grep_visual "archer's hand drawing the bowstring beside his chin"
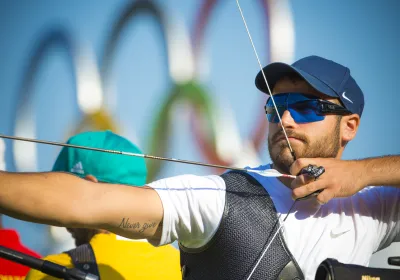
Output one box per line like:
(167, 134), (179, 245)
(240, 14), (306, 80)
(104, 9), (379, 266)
(290, 158), (367, 204)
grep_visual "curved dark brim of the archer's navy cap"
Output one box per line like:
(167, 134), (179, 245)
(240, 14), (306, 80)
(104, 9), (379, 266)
(255, 62), (338, 97)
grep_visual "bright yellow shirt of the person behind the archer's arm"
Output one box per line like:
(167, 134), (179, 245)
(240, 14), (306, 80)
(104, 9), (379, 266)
(26, 233), (182, 280)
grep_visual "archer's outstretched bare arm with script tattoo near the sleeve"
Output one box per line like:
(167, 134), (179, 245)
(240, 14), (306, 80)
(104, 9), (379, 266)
(0, 171), (163, 240)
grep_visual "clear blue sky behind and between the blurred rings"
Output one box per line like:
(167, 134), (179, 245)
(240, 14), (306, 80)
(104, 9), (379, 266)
(0, 0), (400, 262)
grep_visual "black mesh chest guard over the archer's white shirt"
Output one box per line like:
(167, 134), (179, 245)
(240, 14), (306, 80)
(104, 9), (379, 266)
(180, 171), (304, 280)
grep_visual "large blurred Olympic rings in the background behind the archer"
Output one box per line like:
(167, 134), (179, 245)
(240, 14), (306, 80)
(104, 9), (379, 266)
(11, 0), (294, 180)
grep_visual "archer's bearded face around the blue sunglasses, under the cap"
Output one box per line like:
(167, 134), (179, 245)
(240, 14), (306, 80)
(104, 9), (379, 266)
(268, 78), (341, 173)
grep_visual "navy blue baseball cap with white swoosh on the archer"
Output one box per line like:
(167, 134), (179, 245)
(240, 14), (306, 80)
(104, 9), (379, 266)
(255, 55), (364, 117)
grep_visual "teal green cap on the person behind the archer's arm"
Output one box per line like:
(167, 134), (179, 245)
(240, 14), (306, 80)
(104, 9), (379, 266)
(53, 130), (147, 186)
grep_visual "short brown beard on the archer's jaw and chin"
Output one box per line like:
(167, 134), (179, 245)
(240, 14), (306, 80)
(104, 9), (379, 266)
(268, 118), (340, 174)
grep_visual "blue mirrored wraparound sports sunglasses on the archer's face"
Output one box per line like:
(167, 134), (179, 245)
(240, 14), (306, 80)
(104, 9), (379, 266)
(265, 92), (352, 123)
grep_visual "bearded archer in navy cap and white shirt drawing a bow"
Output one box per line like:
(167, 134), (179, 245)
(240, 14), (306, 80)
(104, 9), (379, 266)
(0, 56), (400, 279)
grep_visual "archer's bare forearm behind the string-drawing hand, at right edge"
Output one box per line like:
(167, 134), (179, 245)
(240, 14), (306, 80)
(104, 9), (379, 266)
(355, 156), (400, 187)
